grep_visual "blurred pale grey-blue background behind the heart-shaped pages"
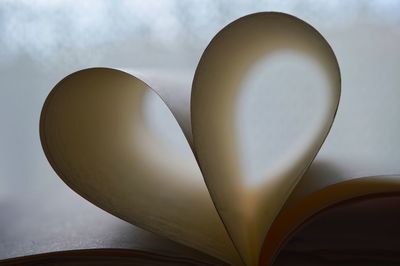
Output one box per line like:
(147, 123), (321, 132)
(0, 0), (400, 258)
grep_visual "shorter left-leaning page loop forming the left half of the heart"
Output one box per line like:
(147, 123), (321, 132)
(40, 68), (240, 265)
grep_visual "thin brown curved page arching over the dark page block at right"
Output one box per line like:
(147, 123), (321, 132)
(260, 176), (400, 265)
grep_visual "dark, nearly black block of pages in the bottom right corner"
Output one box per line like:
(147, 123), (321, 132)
(274, 192), (400, 266)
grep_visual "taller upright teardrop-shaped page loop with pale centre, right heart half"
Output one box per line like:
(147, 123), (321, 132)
(191, 13), (340, 265)
